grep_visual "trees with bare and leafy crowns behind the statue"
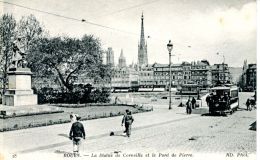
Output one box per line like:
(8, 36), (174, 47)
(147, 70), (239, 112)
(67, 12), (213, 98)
(0, 14), (111, 99)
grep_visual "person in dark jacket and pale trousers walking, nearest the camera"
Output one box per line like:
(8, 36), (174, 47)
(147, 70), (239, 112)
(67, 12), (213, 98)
(69, 115), (85, 153)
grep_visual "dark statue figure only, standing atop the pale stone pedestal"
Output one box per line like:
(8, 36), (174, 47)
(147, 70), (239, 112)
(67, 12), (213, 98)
(12, 37), (27, 68)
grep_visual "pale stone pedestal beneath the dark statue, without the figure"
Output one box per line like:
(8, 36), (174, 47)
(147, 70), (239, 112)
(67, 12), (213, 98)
(3, 68), (38, 106)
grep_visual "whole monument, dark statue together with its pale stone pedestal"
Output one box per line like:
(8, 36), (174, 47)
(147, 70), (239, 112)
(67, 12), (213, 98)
(3, 37), (38, 106)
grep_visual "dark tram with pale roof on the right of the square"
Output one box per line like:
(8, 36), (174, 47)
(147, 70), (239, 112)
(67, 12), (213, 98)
(206, 86), (239, 114)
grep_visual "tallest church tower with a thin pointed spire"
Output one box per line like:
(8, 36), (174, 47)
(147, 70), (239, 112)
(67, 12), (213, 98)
(138, 13), (148, 67)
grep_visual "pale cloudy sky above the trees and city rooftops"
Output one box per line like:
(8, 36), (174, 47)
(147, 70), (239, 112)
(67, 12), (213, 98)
(0, 0), (257, 67)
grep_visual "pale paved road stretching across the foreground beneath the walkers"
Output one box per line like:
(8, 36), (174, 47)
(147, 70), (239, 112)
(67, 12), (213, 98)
(0, 93), (256, 159)
